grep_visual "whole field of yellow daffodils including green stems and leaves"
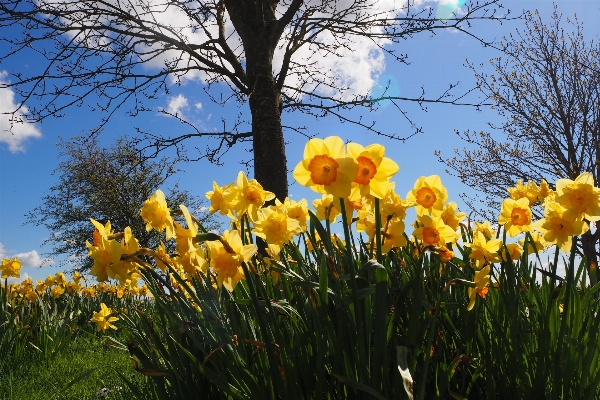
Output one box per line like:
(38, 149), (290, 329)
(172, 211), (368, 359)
(0, 136), (600, 400)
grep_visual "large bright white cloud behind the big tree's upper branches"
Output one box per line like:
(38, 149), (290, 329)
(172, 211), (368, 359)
(49, 0), (458, 105)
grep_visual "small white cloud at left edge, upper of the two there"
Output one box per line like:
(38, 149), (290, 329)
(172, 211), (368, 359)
(0, 71), (42, 153)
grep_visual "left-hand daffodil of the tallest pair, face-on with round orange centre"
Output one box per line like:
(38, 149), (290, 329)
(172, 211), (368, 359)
(294, 136), (358, 198)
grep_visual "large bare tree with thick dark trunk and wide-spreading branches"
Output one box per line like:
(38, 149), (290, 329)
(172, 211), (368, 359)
(0, 0), (507, 199)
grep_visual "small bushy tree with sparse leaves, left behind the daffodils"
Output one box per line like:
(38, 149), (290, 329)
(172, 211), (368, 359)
(27, 138), (218, 271)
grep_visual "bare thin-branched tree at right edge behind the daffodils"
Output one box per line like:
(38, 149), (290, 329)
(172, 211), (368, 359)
(440, 6), (600, 278)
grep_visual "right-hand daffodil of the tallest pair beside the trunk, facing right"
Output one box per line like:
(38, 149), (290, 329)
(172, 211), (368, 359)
(347, 143), (399, 199)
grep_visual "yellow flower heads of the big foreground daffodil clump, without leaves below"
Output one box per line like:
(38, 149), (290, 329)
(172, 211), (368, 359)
(82, 136), (600, 312)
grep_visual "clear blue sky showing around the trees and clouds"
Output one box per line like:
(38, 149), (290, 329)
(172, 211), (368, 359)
(0, 0), (600, 279)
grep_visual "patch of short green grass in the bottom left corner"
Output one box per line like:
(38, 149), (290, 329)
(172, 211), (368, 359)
(0, 327), (149, 400)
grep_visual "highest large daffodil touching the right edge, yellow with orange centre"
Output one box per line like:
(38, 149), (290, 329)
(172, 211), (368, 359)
(556, 172), (600, 221)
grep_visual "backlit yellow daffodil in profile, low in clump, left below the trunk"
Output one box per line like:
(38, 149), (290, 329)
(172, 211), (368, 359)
(207, 230), (258, 292)
